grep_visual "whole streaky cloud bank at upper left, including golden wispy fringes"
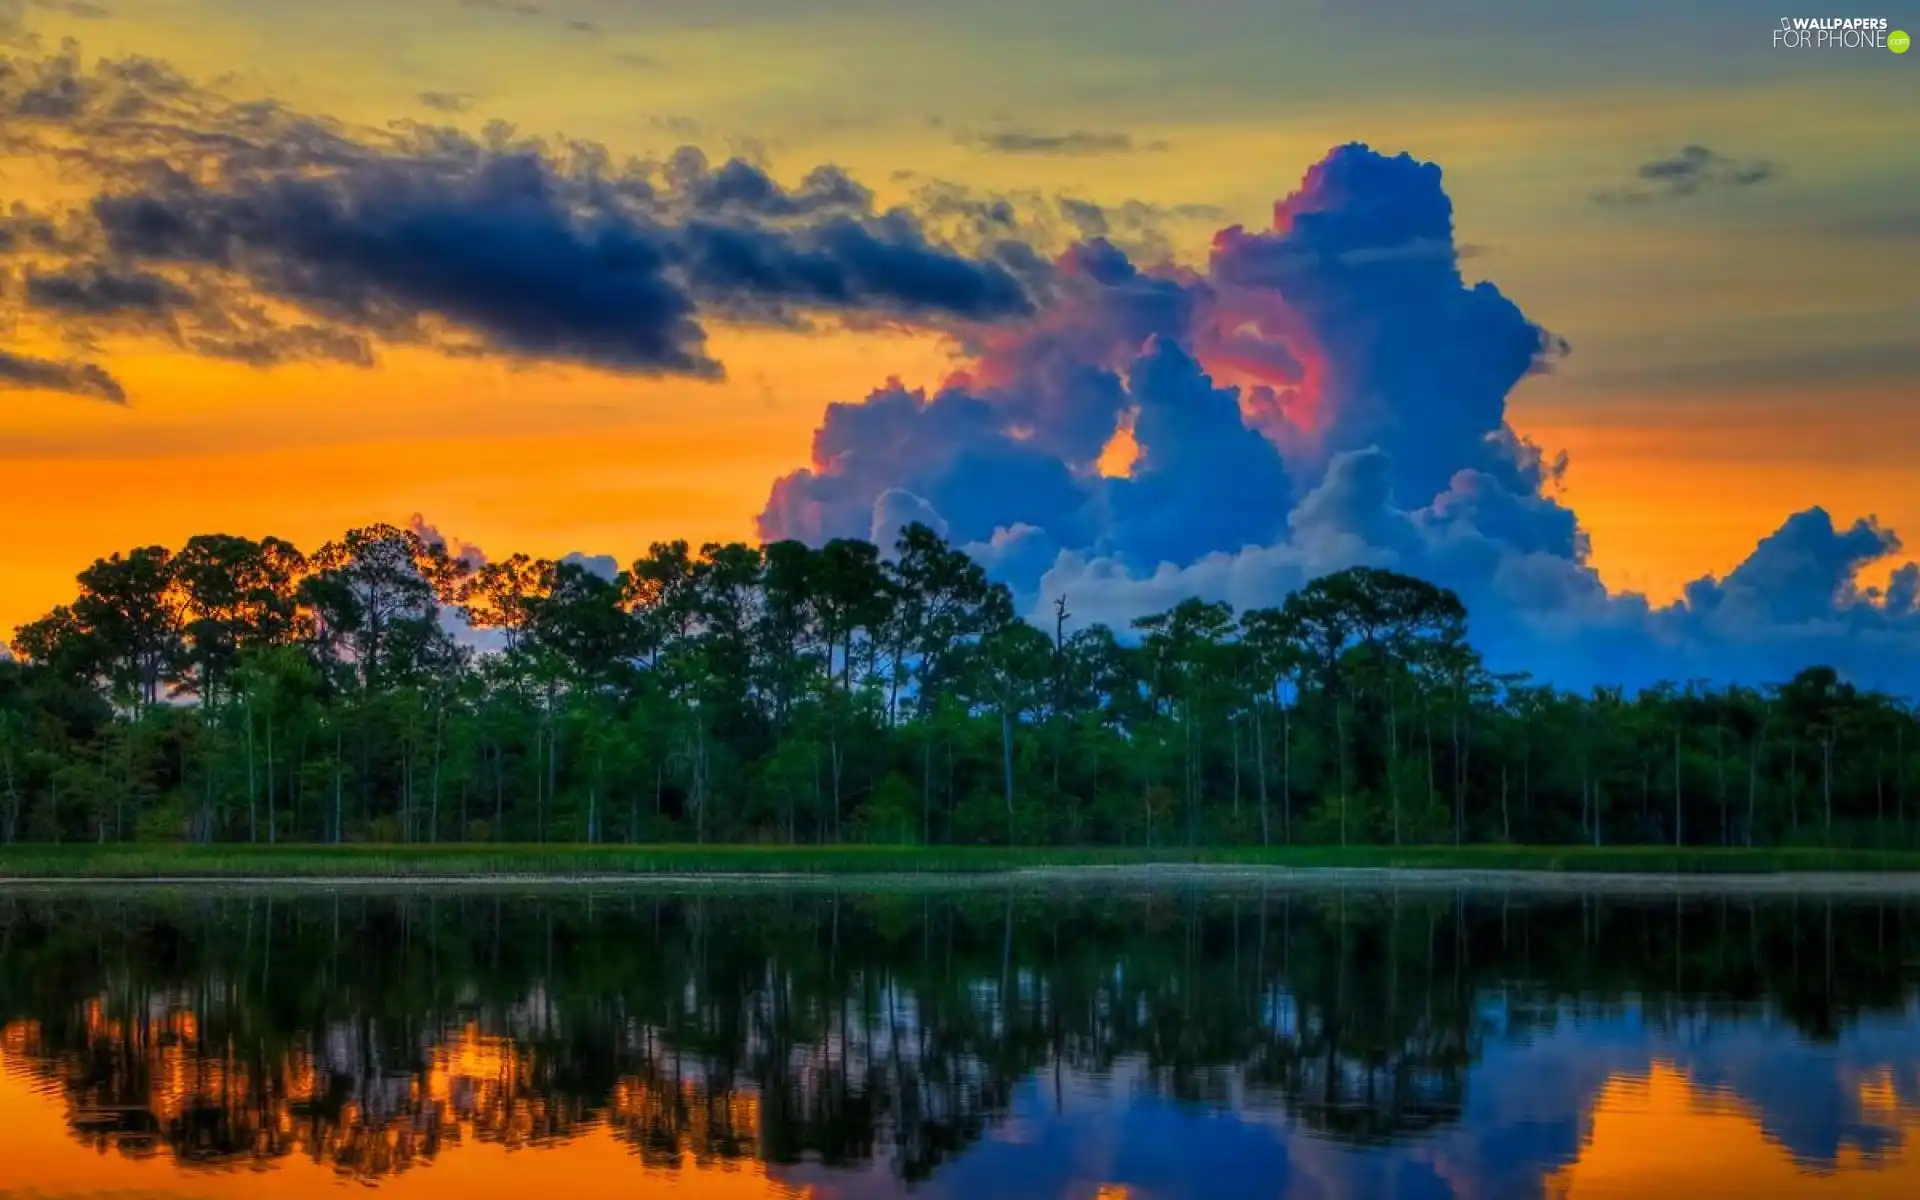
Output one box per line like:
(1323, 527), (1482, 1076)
(0, 46), (1043, 393)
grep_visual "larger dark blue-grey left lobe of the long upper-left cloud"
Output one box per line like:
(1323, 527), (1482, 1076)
(94, 157), (718, 374)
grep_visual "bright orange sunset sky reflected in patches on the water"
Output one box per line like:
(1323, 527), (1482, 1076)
(18, 1023), (1920, 1200)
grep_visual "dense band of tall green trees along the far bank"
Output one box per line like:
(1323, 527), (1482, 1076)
(0, 524), (1920, 847)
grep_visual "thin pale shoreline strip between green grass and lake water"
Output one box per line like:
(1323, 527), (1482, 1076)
(11, 864), (1920, 899)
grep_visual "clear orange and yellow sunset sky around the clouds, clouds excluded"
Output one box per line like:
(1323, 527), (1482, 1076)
(0, 0), (1920, 630)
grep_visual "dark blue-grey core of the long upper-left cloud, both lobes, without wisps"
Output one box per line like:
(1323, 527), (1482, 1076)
(82, 152), (1029, 374)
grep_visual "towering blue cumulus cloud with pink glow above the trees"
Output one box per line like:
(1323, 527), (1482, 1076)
(760, 144), (1920, 687)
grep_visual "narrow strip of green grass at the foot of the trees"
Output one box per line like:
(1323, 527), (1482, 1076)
(0, 845), (1920, 879)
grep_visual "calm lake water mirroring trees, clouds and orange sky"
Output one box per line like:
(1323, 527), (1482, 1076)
(0, 891), (1920, 1200)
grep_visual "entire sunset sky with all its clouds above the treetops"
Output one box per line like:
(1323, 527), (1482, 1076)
(0, 0), (1920, 682)
